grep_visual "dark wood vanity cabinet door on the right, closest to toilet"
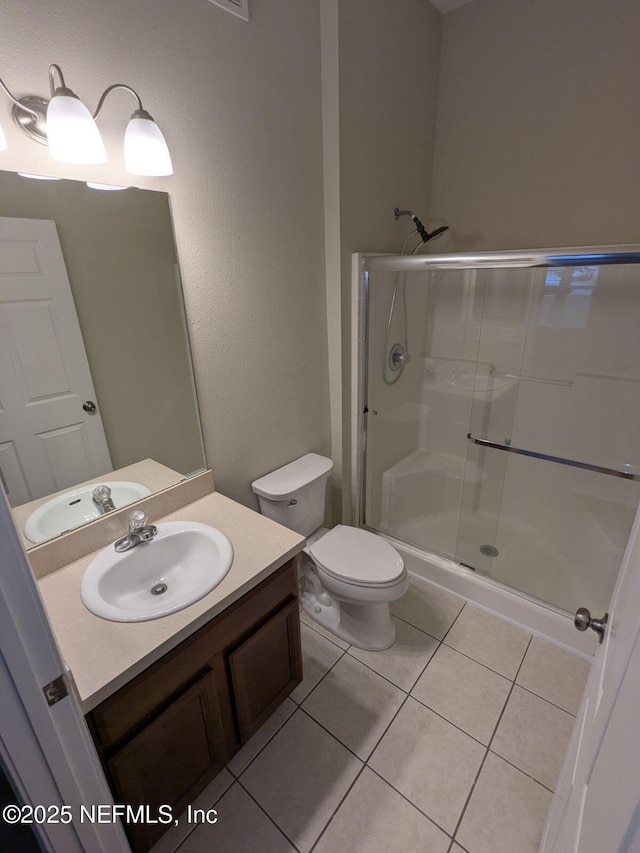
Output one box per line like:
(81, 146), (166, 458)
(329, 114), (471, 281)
(228, 599), (302, 743)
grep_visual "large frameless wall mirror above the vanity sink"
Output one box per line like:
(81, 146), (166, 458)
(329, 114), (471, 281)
(0, 172), (206, 548)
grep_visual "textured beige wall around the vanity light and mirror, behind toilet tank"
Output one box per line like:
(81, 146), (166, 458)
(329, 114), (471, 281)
(0, 0), (329, 506)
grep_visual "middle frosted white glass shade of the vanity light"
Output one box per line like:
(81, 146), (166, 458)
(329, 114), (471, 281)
(47, 95), (107, 164)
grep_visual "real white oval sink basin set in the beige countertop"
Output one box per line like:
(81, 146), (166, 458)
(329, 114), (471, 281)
(80, 521), (233, 622)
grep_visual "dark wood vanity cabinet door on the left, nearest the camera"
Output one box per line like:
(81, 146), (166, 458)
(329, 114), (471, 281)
(107, 670), (225, 851)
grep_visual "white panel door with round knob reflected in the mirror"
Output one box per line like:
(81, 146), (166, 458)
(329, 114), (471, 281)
(0, 217), (113, 506)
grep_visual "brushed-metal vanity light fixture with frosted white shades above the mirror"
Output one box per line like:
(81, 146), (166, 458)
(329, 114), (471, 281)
(0, 65), (173, 177)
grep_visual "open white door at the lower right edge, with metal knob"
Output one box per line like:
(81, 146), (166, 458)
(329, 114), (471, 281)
(540, 500), (640, 853)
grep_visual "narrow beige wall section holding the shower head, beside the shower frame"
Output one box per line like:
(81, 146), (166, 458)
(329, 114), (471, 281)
(325, 0), (441, 517)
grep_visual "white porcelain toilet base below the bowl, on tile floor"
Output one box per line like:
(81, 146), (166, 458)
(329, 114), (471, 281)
(302, 590), (396, 652)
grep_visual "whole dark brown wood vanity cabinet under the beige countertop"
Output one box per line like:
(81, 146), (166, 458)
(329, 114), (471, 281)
(87, 560), (302, 853)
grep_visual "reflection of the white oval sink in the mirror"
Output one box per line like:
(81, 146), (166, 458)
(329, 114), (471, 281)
(24, 480), (151, 545)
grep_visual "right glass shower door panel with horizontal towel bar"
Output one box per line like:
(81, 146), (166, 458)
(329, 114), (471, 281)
(456, 265), (640, 612)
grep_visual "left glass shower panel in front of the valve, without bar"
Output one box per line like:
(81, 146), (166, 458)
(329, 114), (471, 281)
(365, 270), (485, 559)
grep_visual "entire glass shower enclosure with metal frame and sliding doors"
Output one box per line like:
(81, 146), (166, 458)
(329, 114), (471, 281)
(358, 246), (640, 612)
